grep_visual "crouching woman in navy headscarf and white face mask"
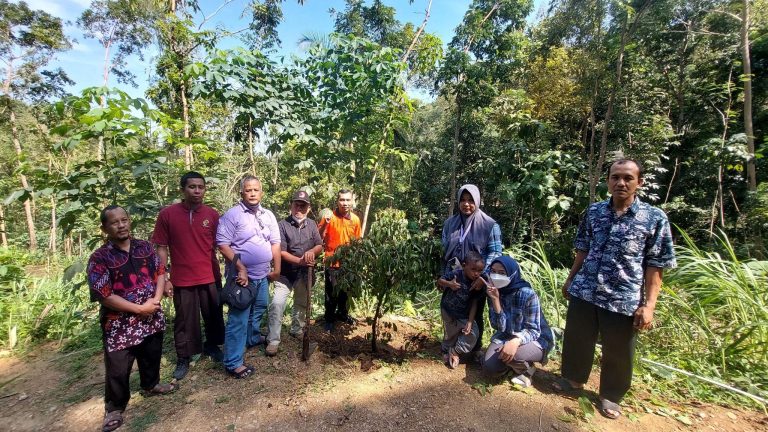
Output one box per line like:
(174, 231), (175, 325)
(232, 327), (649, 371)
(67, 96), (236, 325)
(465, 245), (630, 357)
(483, 256), (554, 387)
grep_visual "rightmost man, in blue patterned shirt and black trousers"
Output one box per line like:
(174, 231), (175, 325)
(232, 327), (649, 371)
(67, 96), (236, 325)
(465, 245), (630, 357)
(554, 159), (676, 419)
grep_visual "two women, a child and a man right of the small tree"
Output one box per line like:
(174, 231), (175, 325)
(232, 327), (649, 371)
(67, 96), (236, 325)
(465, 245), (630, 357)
(437, 159), (676, 419)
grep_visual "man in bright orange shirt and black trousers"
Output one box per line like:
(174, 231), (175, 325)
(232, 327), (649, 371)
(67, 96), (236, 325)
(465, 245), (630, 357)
(319, 189), (362, 331)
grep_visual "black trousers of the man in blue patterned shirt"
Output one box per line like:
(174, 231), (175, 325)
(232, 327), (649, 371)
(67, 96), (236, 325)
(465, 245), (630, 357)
(561, 297), (637, 403)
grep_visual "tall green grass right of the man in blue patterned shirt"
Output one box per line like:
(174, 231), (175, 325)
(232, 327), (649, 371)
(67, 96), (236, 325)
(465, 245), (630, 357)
(648, 232), (768, 404)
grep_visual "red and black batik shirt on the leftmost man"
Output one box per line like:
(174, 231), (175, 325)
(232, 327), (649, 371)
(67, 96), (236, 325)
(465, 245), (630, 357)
(87, 239), (165, 352)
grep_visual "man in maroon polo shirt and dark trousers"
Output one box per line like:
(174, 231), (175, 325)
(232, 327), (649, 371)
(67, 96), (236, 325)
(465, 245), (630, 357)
(152, 171), (224, 380)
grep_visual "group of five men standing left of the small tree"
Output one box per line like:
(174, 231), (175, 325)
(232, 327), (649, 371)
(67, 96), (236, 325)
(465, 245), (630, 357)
(87, 172), (361, 431)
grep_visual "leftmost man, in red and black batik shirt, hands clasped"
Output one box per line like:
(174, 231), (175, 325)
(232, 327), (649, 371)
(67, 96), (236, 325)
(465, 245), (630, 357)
(87, 205), (176, 431)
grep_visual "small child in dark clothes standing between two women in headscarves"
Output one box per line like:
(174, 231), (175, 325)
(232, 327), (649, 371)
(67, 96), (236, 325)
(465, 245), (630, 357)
(437, 251), (485, 369)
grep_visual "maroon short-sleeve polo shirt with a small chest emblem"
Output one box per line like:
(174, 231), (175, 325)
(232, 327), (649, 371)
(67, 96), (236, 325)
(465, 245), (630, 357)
(152, 202), (221, 287)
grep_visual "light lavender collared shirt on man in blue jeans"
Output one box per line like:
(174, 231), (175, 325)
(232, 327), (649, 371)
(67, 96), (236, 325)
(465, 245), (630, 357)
(216, 201), (280, 280)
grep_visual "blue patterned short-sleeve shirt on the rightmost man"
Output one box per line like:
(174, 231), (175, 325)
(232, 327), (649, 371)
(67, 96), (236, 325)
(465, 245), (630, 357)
(568, 198), (677, 316)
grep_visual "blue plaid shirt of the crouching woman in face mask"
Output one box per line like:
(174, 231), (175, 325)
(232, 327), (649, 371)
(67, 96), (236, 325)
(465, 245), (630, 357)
(488, 287), (554, 352)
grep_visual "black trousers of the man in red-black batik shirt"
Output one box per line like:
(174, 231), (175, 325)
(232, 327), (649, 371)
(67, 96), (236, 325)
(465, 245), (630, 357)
(104, 332), (164, 412)
